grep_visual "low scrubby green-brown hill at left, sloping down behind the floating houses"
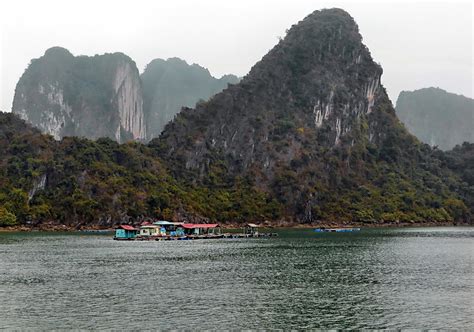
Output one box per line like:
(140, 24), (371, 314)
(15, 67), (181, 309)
(0, 113), (279, 227)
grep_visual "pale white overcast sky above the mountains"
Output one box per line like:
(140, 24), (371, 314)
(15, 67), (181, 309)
(0, 0), (473, 111)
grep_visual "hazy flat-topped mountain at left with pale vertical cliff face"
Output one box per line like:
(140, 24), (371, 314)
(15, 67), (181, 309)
(12, 47), (146, 142)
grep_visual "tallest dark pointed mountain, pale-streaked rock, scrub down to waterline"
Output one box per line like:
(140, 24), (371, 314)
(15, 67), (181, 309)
(157, 9), (468, 221)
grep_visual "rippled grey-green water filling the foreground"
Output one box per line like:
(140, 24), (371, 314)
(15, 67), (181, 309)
(0, 228), (474, 330)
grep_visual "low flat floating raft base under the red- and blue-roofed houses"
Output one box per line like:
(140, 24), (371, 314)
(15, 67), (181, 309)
(114, 233), (278, 241)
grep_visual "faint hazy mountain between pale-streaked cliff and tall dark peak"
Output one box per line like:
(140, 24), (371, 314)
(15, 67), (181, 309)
(141, 58), (239, 139)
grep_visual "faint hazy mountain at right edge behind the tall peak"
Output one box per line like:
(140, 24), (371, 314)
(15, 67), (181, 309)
(396, 88), (474, 150)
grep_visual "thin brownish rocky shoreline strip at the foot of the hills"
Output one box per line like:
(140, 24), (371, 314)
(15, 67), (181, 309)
(0, 222), (474, 233)
